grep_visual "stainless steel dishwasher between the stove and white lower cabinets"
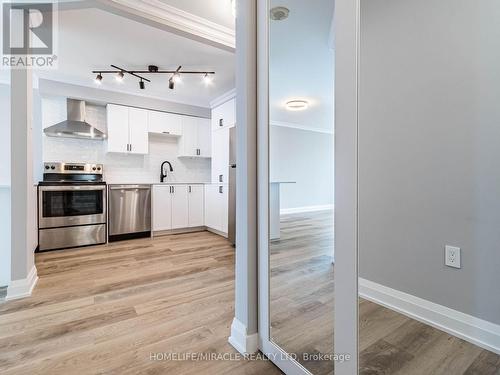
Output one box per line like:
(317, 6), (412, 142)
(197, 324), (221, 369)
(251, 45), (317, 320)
(108, 185), (151, 242)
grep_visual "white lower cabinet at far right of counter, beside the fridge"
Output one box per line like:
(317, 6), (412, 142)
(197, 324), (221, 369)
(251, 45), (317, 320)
(205, 184), (228, 233)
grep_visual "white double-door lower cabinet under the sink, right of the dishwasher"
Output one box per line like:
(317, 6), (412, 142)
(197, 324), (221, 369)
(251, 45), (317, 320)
(152, 185), (205, 232)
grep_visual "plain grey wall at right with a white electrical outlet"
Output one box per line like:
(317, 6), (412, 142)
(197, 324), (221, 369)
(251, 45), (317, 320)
(359, 0), (500, 324)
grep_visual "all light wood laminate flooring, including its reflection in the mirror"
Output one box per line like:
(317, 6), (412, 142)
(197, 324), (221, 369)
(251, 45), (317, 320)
(0, 213), (500, 375)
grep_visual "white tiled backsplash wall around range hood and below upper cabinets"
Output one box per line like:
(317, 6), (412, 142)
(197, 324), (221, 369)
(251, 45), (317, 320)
(42, 96), (210, 183)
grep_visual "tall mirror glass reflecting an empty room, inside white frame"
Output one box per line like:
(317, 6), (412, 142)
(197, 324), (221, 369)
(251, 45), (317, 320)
(269, 0), (334, 374)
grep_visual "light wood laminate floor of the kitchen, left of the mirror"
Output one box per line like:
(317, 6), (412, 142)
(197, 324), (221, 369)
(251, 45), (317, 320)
(0, 232), (281, 375)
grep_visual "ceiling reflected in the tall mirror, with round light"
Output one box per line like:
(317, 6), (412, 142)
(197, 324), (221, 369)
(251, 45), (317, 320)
(269, 0), (334, 131)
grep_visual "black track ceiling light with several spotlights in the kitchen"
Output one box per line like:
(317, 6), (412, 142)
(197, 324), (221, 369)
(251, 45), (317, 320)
(92, 65), (215, 90)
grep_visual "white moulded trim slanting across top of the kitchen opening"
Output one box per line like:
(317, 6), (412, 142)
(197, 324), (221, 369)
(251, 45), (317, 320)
(101, 0), (236, 50)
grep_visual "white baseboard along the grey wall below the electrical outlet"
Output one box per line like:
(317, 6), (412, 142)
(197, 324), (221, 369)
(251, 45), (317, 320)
(359, 278), (500, 354)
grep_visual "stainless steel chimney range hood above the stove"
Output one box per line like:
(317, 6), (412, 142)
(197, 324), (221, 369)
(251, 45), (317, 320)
(43, 99), (106, 140)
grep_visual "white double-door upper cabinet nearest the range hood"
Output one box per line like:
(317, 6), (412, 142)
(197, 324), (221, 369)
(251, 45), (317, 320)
(106, 104), (149, 154)
